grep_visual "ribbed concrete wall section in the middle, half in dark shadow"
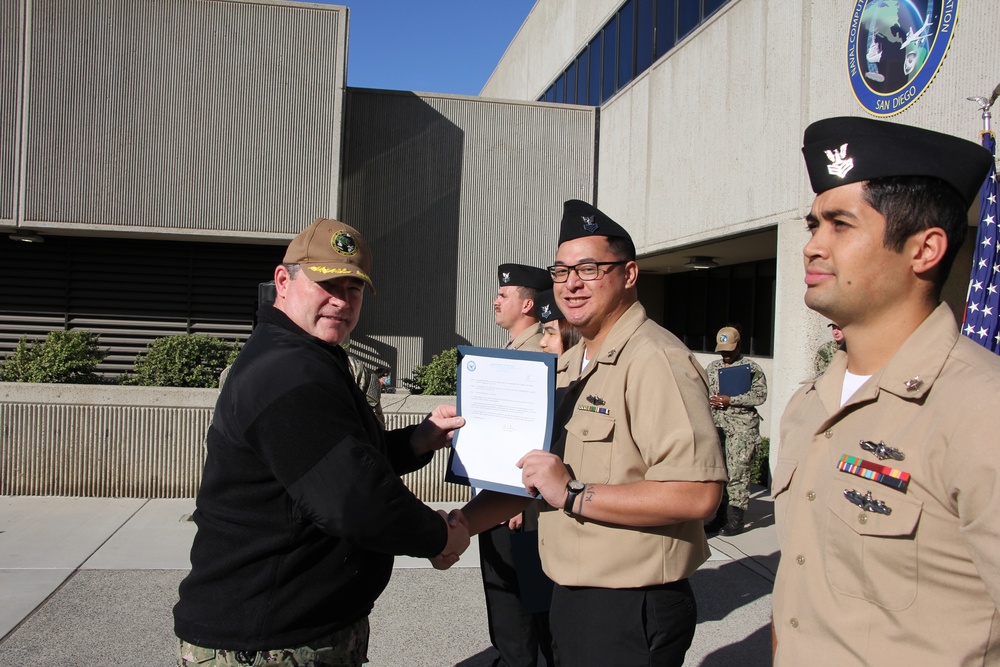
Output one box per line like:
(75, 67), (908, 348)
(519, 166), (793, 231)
(342, 88), (596, 377)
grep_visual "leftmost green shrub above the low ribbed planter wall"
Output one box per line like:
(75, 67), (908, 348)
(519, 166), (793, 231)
(0, 331), (108, 384)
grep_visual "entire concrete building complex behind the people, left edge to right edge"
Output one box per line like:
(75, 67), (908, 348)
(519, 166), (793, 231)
(0, 0), (1000, 460)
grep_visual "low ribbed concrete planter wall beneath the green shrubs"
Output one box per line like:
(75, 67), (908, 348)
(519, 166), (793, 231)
(0, 382), (471, 502)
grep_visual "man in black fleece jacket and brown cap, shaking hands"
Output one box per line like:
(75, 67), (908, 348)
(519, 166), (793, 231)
(174, 219), (469, 665)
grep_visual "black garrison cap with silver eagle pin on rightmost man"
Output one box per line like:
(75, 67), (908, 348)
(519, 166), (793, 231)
(802, 116), (993, 206)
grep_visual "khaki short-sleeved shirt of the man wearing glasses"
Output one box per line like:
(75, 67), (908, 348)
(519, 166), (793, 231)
(539, 303), (726, 588)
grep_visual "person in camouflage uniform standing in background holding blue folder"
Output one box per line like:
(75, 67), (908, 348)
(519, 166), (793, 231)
(705, 327), (767, 535)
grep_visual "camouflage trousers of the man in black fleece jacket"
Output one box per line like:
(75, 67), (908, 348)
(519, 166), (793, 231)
(177, 616), (368, 667)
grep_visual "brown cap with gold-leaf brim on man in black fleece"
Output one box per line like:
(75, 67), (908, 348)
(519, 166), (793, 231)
(283, 218), (375, 294)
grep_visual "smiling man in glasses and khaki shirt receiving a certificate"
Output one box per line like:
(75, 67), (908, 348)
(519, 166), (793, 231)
(453, 200), (726, 667)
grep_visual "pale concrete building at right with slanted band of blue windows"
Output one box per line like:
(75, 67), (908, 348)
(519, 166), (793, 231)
(482, 0), (1000, 452)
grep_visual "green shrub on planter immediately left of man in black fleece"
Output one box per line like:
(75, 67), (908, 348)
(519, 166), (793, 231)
(122, 334), (240, 389)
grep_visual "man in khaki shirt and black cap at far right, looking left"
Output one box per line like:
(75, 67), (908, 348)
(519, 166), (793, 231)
(772, 118), (1000, 667)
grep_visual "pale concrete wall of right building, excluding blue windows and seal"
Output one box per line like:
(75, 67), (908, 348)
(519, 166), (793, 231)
(483, 0), (1000, 462)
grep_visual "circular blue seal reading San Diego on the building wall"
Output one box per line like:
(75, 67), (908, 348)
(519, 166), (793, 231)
(847, 0), (959, 117)
